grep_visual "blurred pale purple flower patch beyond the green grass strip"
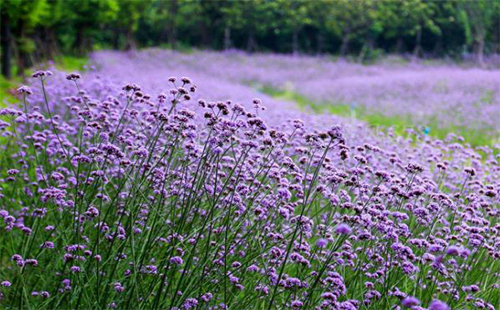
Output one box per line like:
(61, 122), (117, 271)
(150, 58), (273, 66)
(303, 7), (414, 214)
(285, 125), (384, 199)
(94, 50), (500, 135)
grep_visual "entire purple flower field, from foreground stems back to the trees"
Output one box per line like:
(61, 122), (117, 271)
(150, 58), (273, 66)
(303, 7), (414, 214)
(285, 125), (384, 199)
(0, 50), (500, 310)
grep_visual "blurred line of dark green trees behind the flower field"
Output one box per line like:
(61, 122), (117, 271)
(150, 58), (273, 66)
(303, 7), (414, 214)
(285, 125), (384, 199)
(0, 0), (500, 77)
